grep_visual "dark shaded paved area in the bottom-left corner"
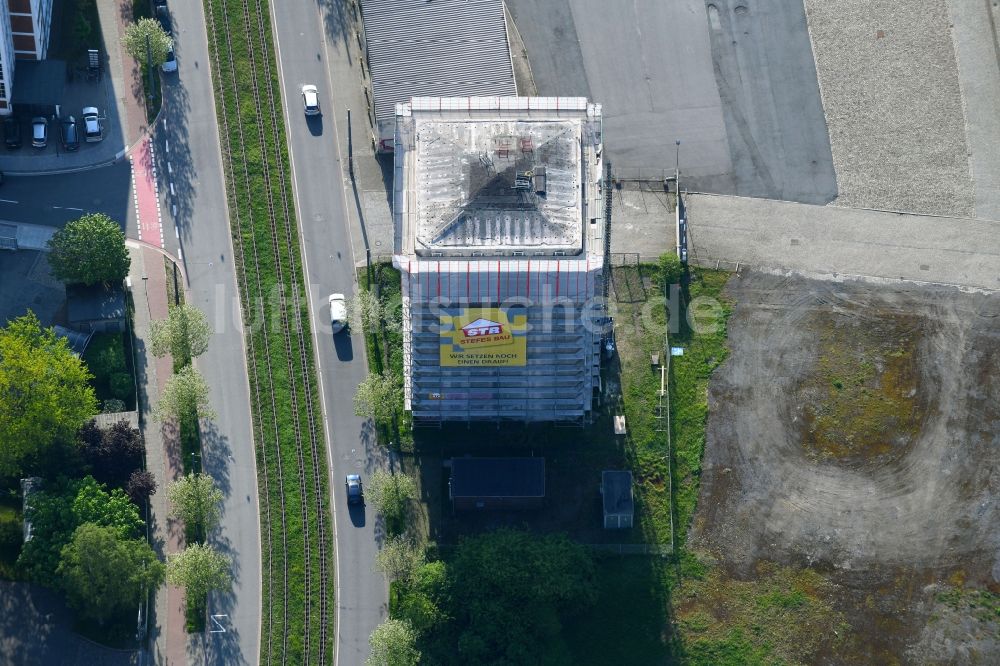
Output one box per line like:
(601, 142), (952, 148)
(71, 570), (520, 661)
(0, 581), (140, 666)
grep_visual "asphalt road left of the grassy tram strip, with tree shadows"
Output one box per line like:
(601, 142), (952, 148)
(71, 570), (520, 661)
(155, 2), (261, 666)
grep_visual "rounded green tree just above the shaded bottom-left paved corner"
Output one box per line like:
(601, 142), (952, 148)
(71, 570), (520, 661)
(57, 523), (164, 624)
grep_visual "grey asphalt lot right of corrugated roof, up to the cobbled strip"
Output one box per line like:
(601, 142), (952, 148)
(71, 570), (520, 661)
(508, 0), (837, 203)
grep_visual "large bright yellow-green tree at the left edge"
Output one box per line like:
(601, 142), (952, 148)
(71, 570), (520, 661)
(0, 312), (97, 476)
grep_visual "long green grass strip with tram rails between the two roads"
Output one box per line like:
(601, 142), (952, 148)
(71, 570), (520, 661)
(205, 0), (334, 663)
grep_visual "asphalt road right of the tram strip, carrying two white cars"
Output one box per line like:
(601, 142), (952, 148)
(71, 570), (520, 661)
(271, 2), (388, 666)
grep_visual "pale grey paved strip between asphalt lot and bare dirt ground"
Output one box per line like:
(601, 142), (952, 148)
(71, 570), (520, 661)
(687, 195), (1000, 290)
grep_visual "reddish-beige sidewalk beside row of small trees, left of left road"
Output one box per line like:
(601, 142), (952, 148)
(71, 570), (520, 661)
(128, 242), (188, 666)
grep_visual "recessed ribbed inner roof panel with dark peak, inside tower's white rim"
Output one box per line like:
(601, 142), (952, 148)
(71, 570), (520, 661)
(415, 119), (583, 251)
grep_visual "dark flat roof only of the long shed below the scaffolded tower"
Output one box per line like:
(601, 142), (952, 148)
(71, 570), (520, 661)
(451, 458), (545, 498)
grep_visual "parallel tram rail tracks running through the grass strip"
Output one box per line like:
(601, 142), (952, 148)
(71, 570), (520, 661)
(206, 0), (330, 665)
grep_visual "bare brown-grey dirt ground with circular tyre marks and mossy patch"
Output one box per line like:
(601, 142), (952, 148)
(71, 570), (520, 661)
(691, 273), (1000, 663)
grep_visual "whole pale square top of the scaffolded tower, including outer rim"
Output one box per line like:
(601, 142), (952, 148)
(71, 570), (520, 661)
(395, 97), (602, 256)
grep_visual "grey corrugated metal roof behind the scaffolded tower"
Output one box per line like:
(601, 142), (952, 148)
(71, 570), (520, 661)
(361, 0), (517, 129)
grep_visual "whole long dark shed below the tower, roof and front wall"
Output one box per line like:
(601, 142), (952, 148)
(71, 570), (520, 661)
(448, 458), (545, 511)
